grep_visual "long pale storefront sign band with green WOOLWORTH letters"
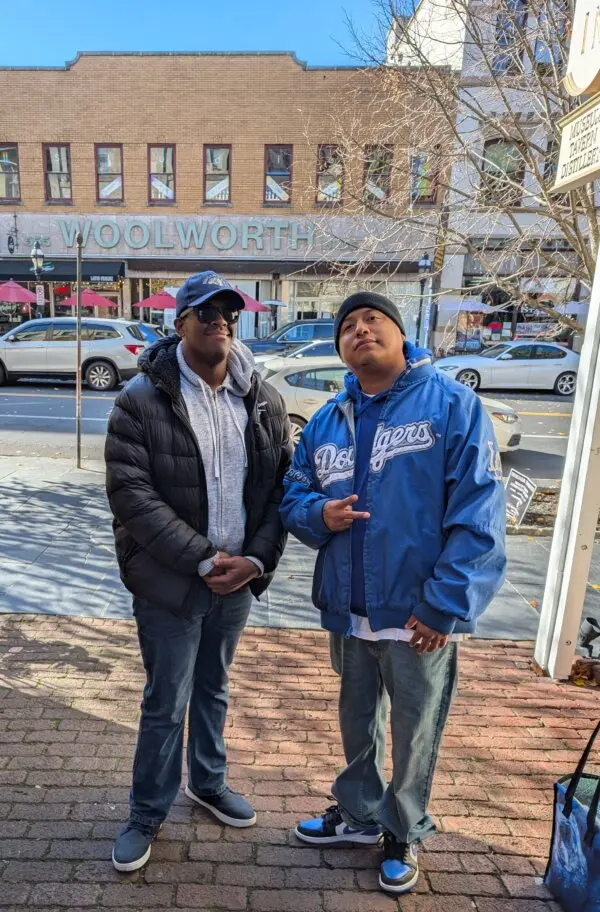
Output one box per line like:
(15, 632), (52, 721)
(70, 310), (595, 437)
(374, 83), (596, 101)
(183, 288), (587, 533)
(0, 211), (427, 268)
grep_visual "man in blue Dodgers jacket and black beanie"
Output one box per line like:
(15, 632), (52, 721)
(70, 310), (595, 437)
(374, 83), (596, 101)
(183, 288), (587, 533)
(282, 292), (505, 894)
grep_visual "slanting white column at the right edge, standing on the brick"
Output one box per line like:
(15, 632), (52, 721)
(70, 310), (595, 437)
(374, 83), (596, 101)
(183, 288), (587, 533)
(535, 248), (600, 679)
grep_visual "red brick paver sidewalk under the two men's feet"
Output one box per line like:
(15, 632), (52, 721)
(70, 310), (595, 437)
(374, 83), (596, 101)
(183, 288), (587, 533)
(0, 615), (598, 912)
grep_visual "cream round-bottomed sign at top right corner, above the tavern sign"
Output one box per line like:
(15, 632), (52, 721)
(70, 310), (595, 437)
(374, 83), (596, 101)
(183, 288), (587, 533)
(564, 0), (600, 97)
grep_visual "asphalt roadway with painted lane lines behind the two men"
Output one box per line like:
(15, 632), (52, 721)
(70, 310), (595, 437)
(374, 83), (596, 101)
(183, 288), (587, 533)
(0, 381), (573, 480)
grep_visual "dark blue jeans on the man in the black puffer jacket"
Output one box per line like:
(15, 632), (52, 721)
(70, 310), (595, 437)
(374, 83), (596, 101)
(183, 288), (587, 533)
(129, 587), (252, 827)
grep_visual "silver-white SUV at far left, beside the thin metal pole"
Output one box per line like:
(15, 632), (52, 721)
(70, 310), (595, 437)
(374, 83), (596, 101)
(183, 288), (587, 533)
(0, 317), (150, 392)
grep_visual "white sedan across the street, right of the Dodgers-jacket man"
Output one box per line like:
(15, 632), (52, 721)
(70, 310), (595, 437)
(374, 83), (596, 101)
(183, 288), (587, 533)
(435, 342), (579, 396)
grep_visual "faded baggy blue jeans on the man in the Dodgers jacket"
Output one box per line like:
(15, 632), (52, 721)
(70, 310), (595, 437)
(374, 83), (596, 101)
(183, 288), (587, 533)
(331, 634), (458, 842)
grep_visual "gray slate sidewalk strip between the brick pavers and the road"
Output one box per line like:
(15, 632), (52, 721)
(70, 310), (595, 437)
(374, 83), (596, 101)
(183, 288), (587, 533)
(0, 456), (600, 640)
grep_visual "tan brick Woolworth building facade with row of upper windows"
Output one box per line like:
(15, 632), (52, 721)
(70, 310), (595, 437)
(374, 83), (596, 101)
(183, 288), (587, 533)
(0, 54), (448, 334)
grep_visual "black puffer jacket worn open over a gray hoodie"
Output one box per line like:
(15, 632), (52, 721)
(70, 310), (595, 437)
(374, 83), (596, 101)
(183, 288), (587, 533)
(105, 336), (291, 614)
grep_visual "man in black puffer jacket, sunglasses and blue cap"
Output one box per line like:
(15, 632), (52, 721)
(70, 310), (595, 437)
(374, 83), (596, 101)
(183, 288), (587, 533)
(106, 272), (291, 871)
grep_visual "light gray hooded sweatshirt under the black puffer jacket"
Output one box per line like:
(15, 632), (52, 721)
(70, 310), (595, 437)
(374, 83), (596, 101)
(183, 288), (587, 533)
(177, 339), (264, 576)
